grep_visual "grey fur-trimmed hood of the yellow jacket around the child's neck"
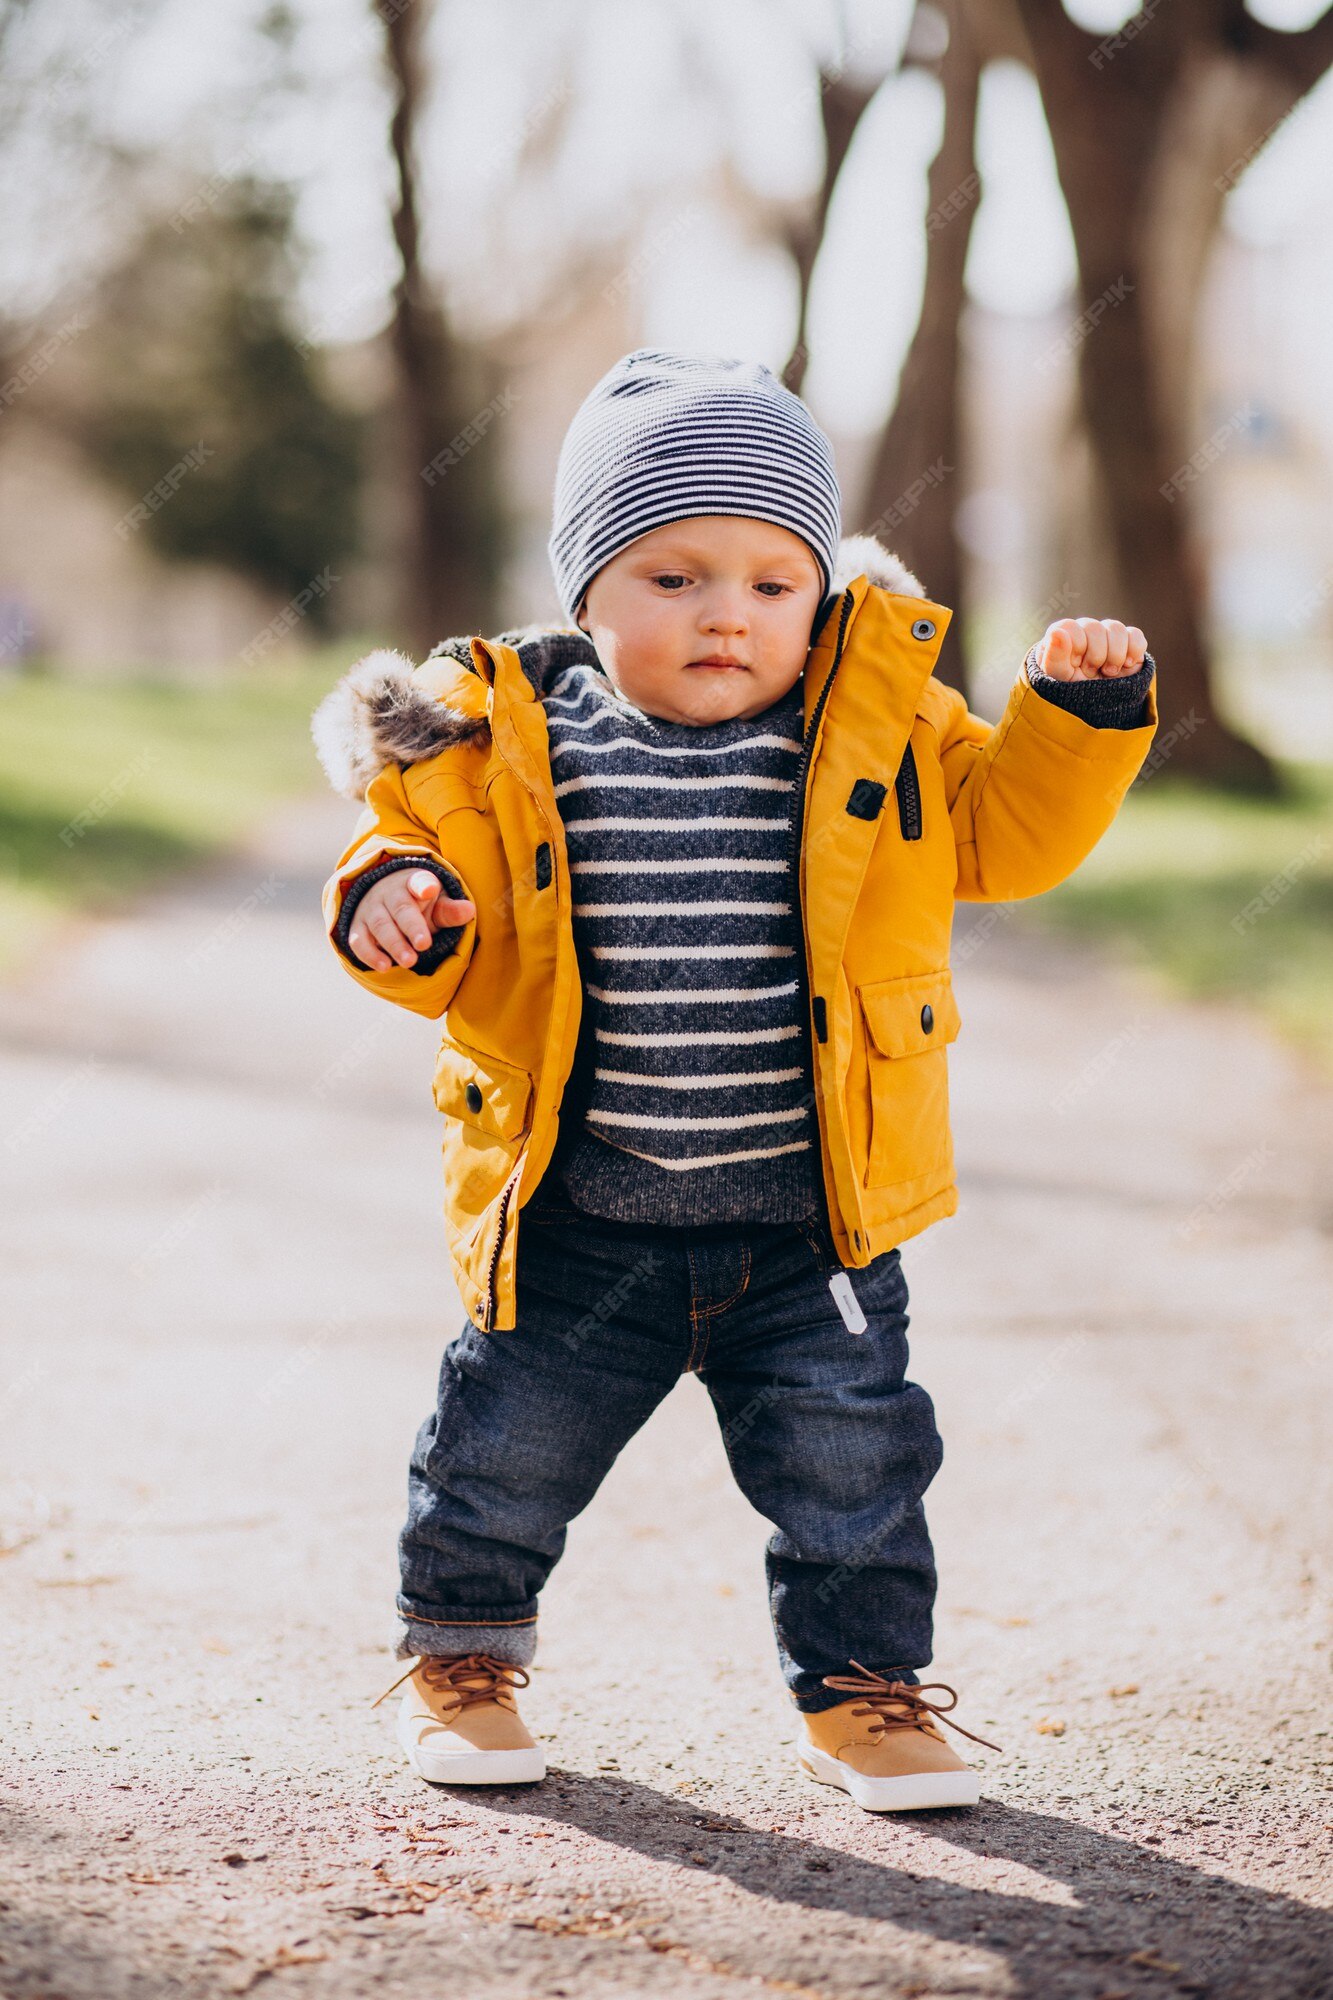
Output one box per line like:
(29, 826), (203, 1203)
(310, 534), (925, 802)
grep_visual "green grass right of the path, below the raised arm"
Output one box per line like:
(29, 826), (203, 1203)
(1035, 764), (1333, 1076)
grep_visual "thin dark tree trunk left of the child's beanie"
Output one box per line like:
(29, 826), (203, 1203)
(374, 0), (504, 654)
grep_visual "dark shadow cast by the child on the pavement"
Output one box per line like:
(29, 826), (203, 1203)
(468, 1770), (1333, 2000)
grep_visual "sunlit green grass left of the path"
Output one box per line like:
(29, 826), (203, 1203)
(0, 646), (354, 970)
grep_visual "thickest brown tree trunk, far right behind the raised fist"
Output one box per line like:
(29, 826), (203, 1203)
(1017, 0), (1333, 790)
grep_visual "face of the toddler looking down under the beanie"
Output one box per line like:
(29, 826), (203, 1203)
(578, 514), (823, 726)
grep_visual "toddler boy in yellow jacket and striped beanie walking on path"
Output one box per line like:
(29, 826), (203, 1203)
(316, 348), (1157, 1812)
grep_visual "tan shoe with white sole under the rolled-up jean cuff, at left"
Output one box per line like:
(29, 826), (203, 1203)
(372, 1652), (546, 1784)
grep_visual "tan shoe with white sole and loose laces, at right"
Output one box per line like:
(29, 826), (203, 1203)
(797, 1660), (999, 1812)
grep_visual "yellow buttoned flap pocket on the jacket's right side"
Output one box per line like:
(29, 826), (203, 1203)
(859, 968), (961, 1188)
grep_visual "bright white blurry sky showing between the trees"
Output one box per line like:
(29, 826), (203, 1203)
(10, 0), (1333, 430)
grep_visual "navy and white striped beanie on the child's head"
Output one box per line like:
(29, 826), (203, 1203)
(546, 348), (843, 620)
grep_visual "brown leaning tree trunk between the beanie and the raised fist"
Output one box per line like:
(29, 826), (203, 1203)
(861, 0), (981, 688)
